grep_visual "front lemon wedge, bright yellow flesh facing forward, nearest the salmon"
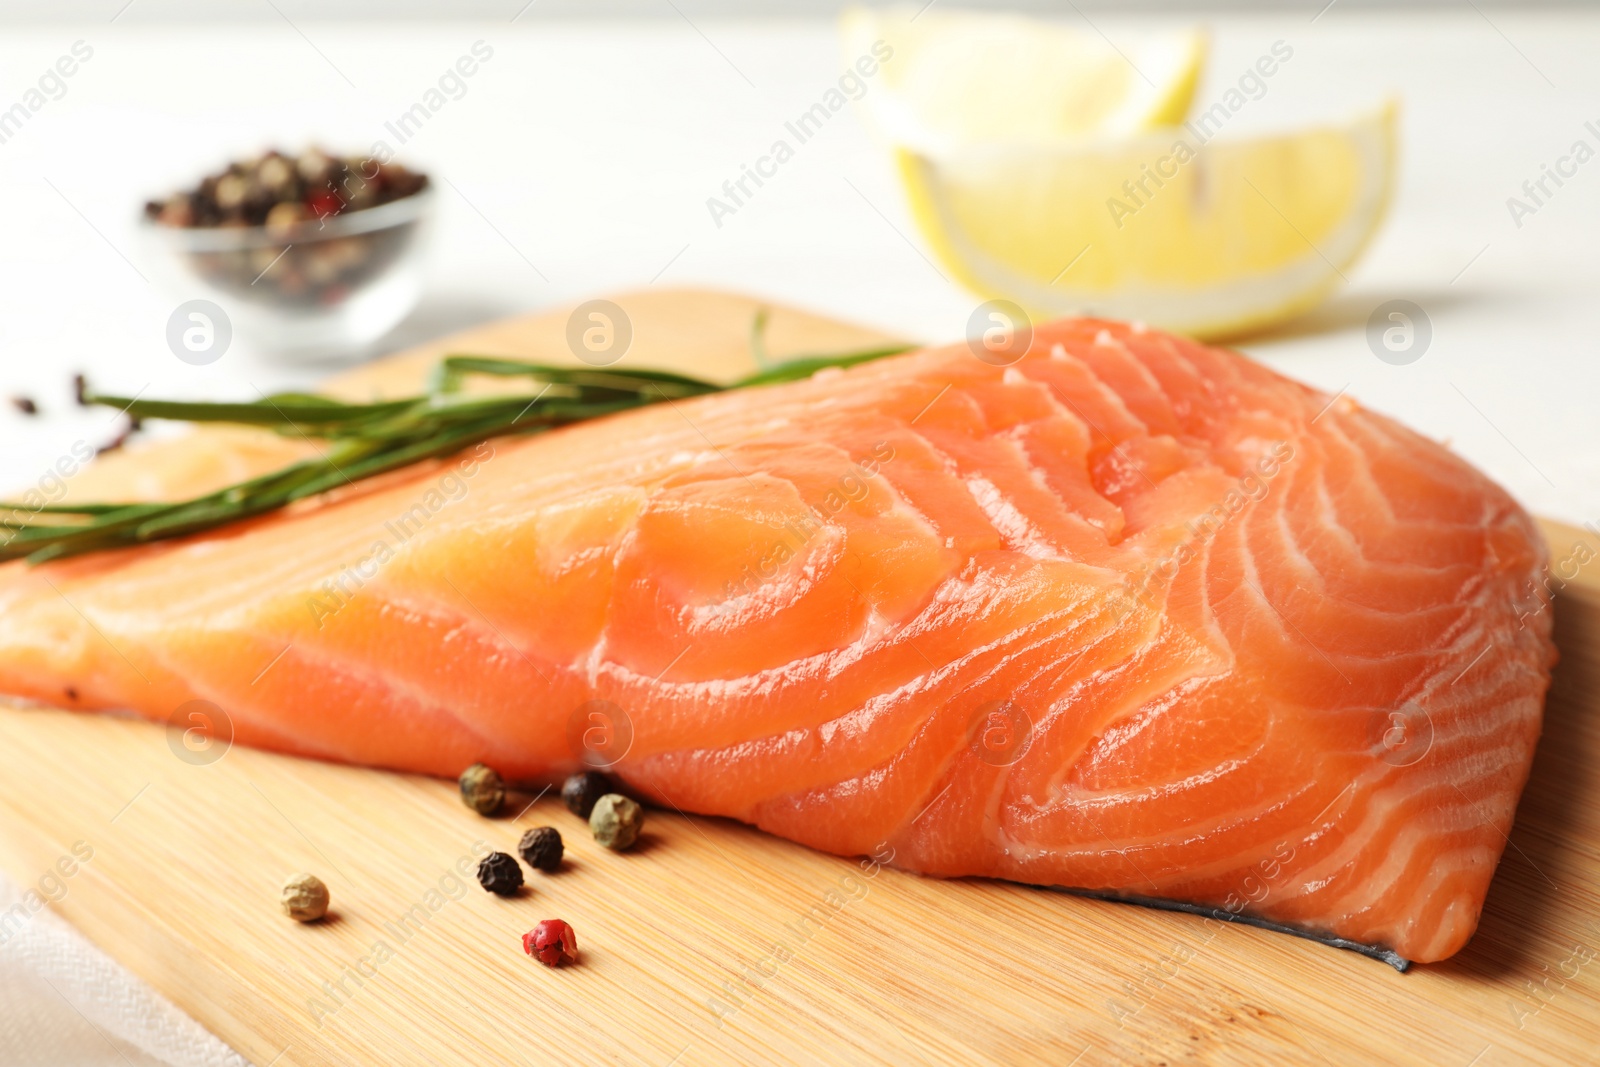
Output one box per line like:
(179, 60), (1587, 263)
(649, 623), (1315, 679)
(896, 102), (1398, 339)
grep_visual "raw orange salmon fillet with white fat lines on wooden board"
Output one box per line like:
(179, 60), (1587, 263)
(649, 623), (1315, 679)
(0, 320), (1555, 961)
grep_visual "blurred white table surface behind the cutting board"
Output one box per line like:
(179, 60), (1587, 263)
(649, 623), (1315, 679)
(0, 6), (1600, 1064)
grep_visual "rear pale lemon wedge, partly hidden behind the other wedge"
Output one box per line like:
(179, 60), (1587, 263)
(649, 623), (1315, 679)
(840, 8), (1206, 155)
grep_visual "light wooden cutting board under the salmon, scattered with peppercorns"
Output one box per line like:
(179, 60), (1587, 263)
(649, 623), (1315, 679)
(0, 293), (1600, 1067)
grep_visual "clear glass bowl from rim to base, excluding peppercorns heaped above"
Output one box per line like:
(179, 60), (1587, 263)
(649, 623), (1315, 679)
(142, 187), (434, 358)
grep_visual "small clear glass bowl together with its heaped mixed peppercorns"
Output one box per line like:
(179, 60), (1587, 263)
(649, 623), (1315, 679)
(144, 149), (434, 357)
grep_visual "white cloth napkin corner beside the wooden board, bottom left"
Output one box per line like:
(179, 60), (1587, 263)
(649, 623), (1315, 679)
(0, 875), (250, 1067)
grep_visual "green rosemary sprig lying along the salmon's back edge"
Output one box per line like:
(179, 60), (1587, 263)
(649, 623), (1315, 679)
(0, 334), (910, 563)
